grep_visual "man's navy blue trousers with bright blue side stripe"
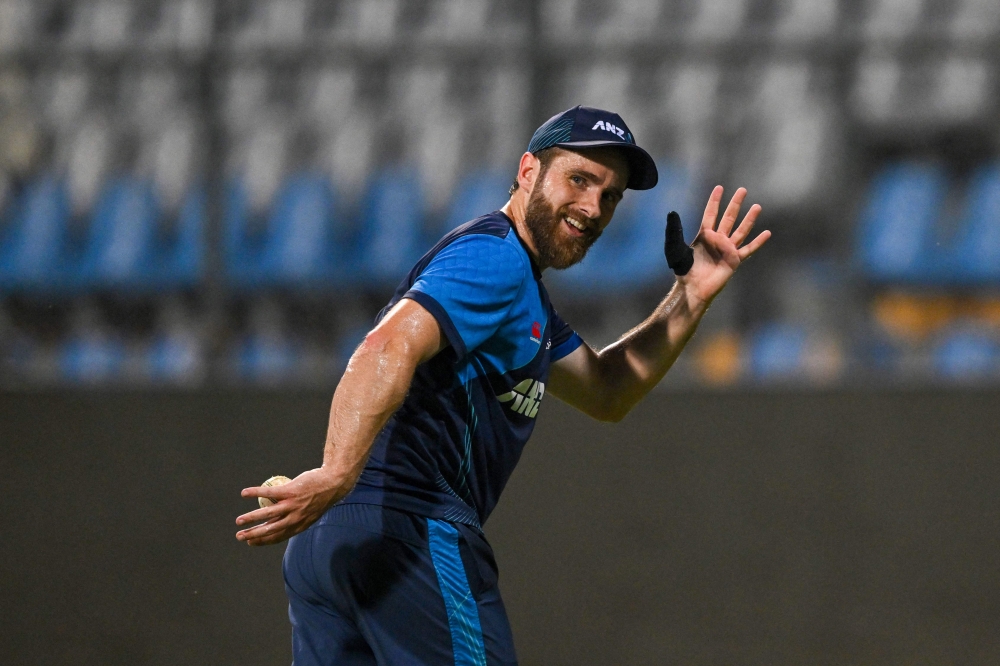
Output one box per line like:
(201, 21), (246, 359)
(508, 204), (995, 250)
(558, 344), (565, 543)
(283, 504), (517, 666)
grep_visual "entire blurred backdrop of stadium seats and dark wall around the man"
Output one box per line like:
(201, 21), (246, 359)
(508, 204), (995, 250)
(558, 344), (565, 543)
(0, 0), (1000, 666)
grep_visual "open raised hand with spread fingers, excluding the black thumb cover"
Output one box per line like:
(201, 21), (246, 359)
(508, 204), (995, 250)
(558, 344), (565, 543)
(668, 185), (771, 303)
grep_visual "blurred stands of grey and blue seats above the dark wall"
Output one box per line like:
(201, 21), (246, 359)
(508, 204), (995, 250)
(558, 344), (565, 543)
(0, 0), (1000, 387)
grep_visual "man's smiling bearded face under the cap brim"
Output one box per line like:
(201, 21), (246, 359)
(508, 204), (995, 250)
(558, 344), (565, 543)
(525, 148), (628, 269)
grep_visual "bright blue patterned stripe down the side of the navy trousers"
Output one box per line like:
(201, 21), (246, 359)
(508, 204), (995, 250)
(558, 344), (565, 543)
(427, 518), (486, 666)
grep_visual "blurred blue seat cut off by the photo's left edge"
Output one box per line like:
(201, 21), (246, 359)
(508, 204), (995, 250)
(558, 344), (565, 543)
(0, 176), (71, 290)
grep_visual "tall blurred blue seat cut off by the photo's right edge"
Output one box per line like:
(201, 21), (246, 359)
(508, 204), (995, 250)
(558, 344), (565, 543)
(948, 164), (1000, 285)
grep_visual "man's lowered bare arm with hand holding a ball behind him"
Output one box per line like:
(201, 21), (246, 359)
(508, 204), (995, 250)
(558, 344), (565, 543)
(236, 298), (447, 546)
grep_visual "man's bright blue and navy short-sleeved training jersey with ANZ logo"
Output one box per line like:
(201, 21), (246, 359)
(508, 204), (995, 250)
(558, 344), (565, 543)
(343, 211), (583, 527)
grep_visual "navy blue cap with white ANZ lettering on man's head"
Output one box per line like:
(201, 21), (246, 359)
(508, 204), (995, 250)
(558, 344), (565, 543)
(528, 106), (659, 190)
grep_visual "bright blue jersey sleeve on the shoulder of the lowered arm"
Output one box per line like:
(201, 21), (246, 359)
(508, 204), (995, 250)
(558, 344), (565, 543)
(404, 234), (527, 357)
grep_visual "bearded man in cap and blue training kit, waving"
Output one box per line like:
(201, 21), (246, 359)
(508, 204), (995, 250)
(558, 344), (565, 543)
(237, 107), (770, 666)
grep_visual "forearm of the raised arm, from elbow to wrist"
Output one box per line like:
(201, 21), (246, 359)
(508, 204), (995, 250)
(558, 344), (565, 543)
(598, 281), (709, 416)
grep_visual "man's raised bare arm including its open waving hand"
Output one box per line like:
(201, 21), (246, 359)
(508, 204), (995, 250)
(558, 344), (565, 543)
(548, 186), (771, 421)
